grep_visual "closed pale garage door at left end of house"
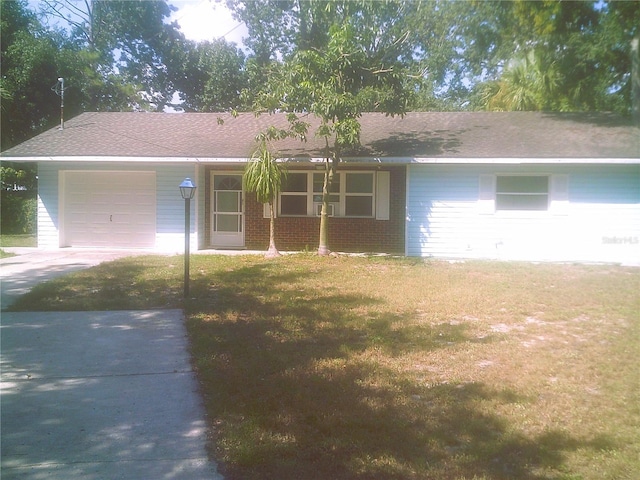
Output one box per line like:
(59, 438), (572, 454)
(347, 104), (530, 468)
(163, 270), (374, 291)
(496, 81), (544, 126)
(63, 171), (156, 248)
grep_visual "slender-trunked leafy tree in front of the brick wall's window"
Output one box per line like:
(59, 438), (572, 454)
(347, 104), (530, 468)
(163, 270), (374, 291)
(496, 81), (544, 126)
(254, 16), (410, 255)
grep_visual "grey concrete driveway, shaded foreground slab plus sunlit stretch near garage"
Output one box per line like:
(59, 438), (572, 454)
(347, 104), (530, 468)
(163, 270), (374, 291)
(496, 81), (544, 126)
(0, 250), (222, 480)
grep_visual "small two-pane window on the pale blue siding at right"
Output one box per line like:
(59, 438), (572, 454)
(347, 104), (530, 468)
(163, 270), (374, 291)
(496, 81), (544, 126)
(496, 175), (549, 210)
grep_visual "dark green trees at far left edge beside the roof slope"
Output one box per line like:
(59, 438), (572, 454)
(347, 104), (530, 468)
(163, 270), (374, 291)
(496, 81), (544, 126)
(1, 1), (162, 150)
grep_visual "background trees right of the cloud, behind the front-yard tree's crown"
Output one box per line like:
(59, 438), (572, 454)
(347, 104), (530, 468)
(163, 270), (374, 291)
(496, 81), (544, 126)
(232, 0), (640, 113)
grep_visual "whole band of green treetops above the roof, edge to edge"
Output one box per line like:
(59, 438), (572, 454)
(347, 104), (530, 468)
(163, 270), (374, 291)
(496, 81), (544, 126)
(0, 0), (640, 153)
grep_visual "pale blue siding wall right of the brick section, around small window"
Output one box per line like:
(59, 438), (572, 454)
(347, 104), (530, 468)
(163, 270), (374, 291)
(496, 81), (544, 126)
(406, 165), (640, 263)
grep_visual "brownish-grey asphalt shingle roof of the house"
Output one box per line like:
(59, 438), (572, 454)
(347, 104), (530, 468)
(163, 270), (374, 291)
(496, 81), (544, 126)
(2, 112), (640, 161)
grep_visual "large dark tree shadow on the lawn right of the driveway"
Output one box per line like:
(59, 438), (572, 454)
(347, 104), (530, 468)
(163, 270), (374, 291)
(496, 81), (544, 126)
(188, 263), (611, 480)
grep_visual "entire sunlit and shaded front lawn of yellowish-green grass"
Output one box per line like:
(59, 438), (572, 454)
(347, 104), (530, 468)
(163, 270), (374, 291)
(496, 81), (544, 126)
(6, 255), (640, 480)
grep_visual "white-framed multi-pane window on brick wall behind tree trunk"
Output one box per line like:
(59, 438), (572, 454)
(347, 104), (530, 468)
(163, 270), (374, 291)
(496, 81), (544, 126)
(278, 172), (380, 218)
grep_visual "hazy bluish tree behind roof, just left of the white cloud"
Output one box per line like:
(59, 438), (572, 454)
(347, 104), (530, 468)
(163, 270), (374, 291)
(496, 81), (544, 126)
(41, 0), (184, 111)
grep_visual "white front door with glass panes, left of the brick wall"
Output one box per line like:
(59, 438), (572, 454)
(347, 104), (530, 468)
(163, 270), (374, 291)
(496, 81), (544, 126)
(211, 172), (244, 248)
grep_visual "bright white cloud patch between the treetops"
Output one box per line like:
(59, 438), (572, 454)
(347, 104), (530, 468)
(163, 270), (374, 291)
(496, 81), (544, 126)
(170, 0), (248, 47)
